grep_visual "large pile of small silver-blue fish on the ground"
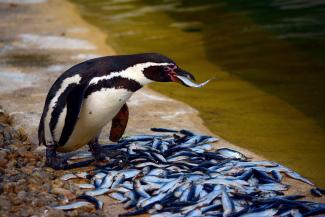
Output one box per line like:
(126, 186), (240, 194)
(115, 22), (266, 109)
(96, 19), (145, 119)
(55, 128), (325, 217)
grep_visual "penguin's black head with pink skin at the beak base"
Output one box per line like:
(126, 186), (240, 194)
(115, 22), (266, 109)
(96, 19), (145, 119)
(143, 54), (195, 86)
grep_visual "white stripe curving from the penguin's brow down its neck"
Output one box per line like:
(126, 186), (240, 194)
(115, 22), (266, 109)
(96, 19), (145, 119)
(89, 62), (170, 85)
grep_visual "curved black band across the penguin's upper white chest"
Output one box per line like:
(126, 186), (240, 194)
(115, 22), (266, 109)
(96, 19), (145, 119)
(85, 76), (142, 98)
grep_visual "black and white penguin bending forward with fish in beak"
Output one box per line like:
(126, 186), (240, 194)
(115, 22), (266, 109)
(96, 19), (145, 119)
(38, 53), (195, 169)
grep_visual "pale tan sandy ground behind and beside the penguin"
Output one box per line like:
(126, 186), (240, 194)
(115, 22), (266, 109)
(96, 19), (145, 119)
(0, 0), (325, 216)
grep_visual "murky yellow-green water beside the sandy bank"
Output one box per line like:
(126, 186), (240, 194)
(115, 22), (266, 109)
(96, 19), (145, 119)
(72, 0), (325, 186)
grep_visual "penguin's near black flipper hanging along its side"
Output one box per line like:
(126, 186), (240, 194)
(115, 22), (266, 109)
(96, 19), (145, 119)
(59, 84), (88, 146)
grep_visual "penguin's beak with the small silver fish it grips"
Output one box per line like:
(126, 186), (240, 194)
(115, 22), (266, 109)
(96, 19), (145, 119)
(170, 68), (211, 88)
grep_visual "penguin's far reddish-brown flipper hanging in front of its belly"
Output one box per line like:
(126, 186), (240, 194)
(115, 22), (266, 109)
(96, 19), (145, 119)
(109, 104), (129, 142)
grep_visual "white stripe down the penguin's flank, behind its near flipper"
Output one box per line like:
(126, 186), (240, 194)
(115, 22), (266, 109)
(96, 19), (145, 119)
(45, 75), (81, 141)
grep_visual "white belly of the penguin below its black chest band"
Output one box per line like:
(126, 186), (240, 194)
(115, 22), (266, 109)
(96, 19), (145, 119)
(58, 88), (133, 152)
